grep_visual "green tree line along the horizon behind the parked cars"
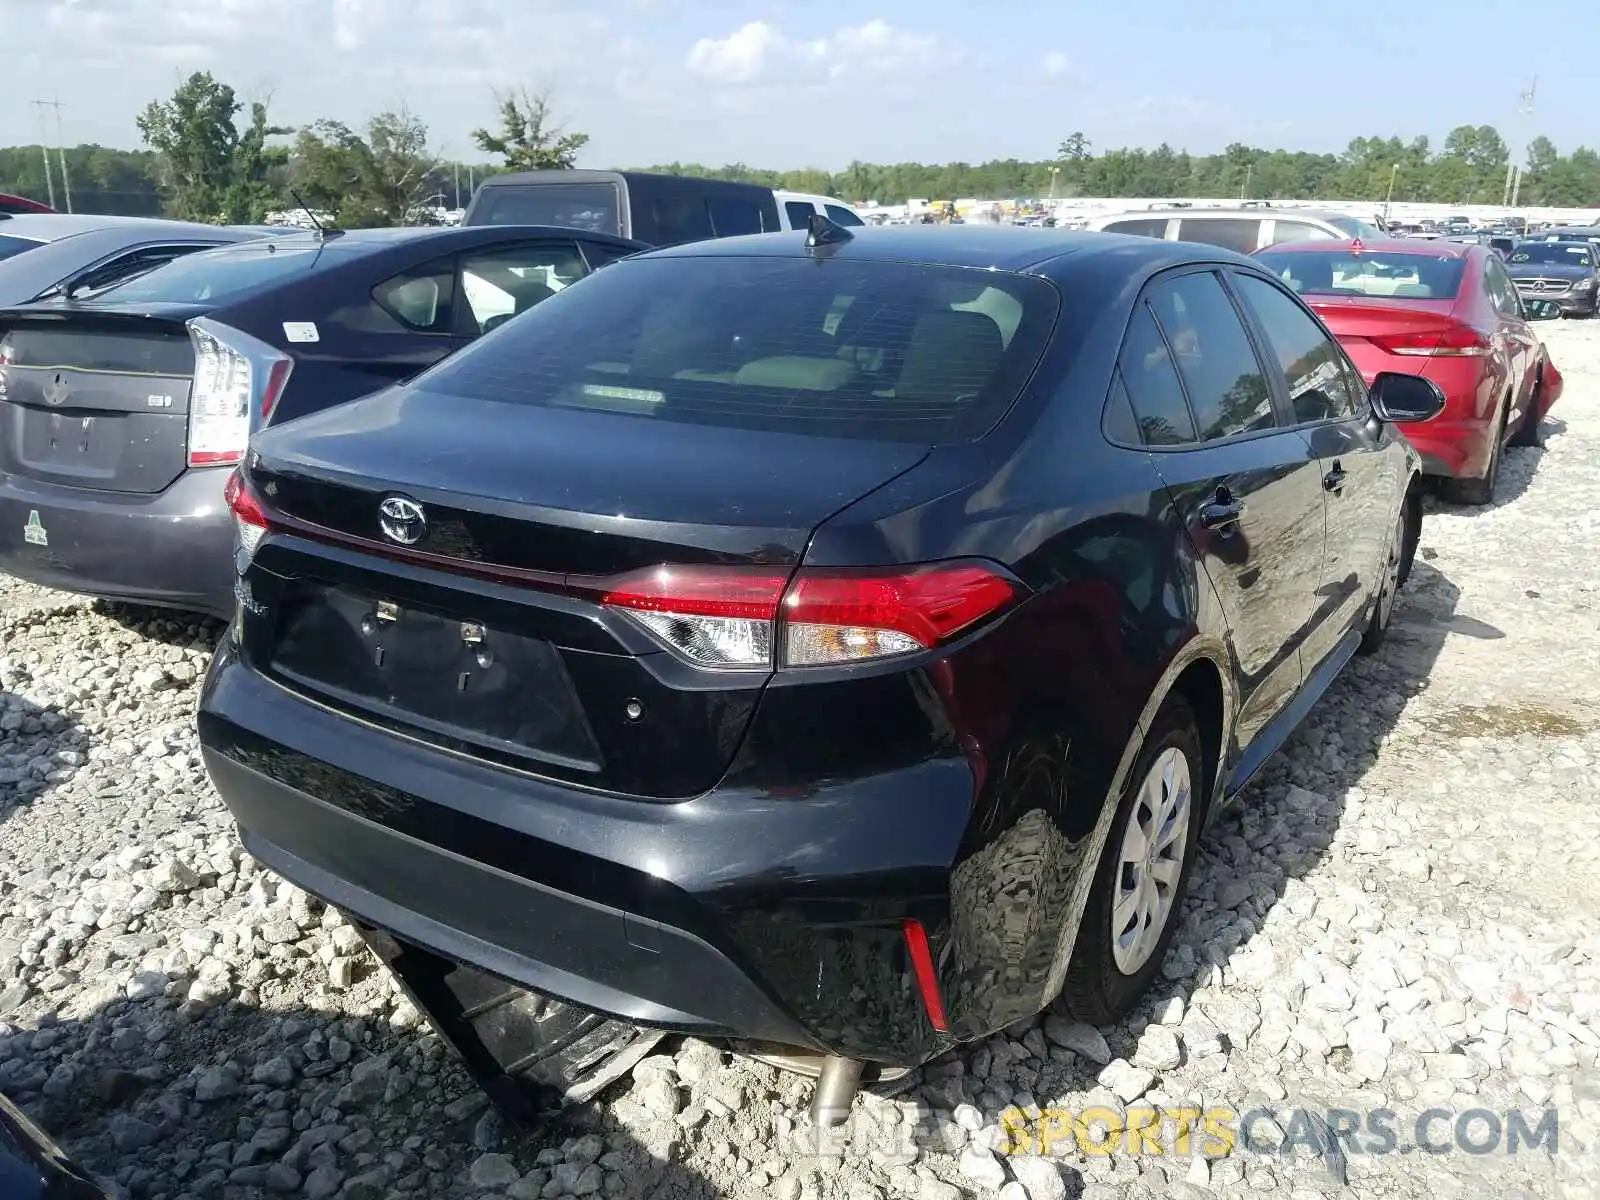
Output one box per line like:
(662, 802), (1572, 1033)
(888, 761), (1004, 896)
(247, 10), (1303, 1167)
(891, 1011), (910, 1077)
(0, 72), (1600, 227)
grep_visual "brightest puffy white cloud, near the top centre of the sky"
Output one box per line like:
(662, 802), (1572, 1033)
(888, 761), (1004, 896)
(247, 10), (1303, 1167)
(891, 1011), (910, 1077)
(686, 19), (962, 85)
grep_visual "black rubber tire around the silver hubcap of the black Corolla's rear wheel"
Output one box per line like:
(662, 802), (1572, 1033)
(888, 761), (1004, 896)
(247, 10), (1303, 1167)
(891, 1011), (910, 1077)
(1056, 694), (1205, 1026)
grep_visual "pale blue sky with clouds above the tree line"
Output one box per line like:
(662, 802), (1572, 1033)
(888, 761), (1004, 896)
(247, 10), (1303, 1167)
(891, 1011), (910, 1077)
(0, 0), (1600, 168)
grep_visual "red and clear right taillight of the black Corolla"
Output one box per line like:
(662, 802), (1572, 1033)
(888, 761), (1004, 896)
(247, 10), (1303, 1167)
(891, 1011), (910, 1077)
(600, 560), (1018, 669)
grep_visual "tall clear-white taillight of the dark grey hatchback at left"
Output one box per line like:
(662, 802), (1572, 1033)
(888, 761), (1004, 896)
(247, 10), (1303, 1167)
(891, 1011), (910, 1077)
(189, 317), (294, 467)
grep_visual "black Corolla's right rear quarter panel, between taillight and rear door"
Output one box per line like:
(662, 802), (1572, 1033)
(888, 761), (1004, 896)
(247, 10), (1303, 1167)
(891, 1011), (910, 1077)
(744, 272), (1232, 1037)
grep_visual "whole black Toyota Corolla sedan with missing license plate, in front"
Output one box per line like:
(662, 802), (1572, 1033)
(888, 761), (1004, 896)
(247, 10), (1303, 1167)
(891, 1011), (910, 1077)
(198, 221), (1442, 1126)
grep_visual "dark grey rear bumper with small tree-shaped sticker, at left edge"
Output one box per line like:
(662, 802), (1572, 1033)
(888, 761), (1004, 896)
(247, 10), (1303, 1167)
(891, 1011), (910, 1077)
(0, 469), (234, 621)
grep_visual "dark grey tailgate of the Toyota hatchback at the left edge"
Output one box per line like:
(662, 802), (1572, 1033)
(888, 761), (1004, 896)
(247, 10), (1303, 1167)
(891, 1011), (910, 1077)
(0, 309), (194, 494)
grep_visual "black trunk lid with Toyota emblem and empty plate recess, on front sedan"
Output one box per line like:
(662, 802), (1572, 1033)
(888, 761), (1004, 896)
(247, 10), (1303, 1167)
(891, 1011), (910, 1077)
(240, 389), (926, 798)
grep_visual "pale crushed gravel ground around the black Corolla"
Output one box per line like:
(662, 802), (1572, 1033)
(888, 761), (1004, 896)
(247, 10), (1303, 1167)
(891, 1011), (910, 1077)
(0, 323), (1600, 1200)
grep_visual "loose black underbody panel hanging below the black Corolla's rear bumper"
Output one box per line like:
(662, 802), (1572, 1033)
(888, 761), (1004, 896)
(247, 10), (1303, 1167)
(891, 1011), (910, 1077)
(357, 925), (664, 1126)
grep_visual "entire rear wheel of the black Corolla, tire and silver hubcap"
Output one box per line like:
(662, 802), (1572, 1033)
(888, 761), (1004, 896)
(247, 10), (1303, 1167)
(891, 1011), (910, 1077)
(1059, 696), (1203, 1026)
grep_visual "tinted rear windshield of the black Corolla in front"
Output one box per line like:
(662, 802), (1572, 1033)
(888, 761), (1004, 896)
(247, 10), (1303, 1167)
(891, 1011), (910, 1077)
(416, 258), (1059, 443)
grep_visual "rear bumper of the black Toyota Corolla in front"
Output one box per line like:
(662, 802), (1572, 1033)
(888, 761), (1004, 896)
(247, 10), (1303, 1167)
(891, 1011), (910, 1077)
(200, 645), (973, 1066)
